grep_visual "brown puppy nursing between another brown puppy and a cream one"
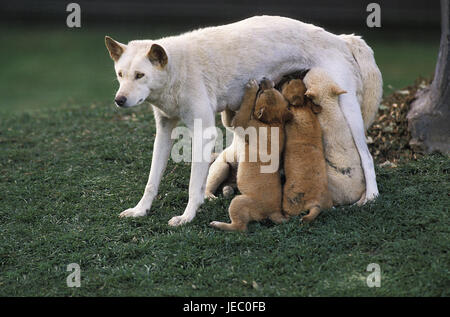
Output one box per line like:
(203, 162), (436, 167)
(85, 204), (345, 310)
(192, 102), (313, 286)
(281, 79), (333, 222)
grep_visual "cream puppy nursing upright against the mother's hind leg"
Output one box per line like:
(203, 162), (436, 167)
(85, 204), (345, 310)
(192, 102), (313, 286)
(303, 68), (366, 206)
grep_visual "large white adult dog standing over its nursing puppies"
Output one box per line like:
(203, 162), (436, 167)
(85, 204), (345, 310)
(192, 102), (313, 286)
(105, 16), (381, 226)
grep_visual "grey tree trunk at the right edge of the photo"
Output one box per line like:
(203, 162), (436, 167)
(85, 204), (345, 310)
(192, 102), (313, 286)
(407, 0), (450, 154)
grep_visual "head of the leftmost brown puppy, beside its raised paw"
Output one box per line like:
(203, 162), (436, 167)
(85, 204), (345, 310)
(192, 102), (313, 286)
(253, 79), (292, 124)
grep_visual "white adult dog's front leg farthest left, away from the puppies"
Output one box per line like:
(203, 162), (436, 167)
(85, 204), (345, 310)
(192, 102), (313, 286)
(119, 108), (178, 217)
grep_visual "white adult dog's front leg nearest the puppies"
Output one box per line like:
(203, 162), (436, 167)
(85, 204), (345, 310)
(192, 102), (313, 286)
(169, 104), (217, 226)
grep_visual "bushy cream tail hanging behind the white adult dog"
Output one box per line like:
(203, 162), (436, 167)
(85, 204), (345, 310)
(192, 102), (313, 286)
(339, 34), (383, 130)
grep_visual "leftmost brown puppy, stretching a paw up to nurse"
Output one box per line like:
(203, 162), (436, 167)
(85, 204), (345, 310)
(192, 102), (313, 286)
(211, 80), (292, 231)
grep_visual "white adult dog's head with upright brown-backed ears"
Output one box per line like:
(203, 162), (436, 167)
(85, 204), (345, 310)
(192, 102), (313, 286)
(105, 36), (168, 108)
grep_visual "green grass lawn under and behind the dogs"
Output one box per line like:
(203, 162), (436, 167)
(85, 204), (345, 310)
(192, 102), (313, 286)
(0, 23), (450, 296)
